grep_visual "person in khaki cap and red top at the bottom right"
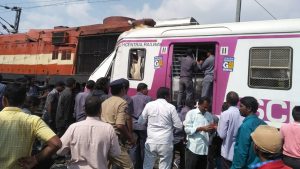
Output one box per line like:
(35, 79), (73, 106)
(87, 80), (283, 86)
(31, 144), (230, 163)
(250, 125), (291, 169)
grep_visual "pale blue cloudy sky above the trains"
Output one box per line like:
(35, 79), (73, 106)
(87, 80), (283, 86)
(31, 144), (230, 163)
(0, 0), (300, 33)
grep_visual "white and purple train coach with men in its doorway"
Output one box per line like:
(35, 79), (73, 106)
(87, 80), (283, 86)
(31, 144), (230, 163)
(90, 19), (300, 127)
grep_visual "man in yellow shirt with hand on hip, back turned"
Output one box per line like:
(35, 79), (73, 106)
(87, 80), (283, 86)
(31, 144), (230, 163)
(0, 83), (61, 169)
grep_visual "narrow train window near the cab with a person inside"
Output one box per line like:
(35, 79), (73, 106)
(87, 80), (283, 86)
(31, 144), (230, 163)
(128, 49), (146, 80)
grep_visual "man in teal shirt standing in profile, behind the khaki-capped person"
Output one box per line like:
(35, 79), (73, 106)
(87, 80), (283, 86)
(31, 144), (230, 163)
(231, 96), (266, 169)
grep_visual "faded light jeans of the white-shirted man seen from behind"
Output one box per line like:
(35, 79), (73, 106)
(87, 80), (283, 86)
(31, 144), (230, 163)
(143, 143), (173, 169)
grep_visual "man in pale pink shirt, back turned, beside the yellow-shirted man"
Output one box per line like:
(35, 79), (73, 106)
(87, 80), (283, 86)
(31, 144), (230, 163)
(57, 96), (121, 169)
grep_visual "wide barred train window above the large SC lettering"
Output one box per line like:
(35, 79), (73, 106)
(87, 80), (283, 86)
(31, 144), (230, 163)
(248, 47), (292, 90)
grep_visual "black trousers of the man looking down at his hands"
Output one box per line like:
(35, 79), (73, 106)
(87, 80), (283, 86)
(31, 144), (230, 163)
(185, 148), (207, 169)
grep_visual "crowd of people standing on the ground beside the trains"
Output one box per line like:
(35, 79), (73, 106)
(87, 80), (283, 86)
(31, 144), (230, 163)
(0, 65), (300, 169)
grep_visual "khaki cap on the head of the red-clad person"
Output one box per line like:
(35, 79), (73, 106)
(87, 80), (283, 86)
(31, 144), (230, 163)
(251, 125), (282, 154)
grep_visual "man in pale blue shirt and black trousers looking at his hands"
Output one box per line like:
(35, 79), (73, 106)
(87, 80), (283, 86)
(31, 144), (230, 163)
(184, 97), (214, 169)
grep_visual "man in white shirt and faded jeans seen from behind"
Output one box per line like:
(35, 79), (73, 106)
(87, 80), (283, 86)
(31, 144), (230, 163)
(139, 87), (182, 169)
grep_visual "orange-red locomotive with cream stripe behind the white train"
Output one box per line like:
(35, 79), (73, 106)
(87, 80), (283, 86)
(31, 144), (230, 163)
(0, 16), (154, 82)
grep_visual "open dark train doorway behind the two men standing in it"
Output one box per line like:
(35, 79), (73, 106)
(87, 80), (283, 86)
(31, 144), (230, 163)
(168, 42), (217, 105)
